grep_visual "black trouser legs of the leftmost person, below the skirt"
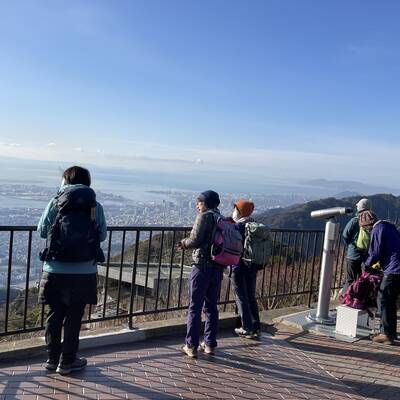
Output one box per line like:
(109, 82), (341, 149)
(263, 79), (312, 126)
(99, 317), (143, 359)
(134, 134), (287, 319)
(45, 300), (86, 364)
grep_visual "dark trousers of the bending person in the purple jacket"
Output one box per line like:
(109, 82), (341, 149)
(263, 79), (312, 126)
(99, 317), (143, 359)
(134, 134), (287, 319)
(378, 274), (400, 339)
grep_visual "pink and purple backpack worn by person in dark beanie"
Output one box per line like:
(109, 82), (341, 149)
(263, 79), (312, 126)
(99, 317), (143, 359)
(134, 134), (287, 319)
(211, 214), (243, 267)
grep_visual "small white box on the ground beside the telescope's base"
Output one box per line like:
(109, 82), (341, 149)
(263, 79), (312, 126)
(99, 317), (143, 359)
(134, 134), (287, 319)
(336, 305), (372, 337)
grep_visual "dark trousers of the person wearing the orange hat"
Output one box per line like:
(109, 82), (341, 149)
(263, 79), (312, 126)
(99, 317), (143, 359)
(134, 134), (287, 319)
(231, 264), (261, 332)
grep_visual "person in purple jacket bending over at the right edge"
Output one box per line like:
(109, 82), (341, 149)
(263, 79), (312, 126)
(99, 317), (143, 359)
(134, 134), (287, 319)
(360, 211), (400, 344)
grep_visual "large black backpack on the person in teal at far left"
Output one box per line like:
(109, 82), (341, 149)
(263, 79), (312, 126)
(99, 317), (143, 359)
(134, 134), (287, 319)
(40, 186), (104, 262)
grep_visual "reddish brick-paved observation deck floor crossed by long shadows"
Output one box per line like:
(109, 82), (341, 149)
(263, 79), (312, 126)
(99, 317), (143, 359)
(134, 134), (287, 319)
(0, 316), (400, 400)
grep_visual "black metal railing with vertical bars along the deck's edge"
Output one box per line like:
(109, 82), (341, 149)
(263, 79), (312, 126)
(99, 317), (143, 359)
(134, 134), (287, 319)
(0, 226), (345, 336)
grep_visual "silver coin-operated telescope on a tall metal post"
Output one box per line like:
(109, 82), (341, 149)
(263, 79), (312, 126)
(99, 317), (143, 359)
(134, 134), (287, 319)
(307, 207), (353, 325)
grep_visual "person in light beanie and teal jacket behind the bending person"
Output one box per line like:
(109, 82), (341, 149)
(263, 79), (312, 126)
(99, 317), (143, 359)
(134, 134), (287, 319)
(342, 198), (371, 291)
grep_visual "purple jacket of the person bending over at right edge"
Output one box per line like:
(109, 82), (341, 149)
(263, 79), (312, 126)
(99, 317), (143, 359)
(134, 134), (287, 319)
(365, 221), (400, 275)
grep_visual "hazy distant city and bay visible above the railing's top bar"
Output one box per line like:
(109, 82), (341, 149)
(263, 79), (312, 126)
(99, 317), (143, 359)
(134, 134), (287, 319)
(0, 184), (311, 226)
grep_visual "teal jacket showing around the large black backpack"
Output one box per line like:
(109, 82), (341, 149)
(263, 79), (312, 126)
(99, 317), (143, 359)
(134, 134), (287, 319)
(37, 185), (107, 274)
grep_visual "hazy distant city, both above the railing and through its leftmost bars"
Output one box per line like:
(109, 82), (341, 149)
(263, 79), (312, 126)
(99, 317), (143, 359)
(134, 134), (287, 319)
(0, 183), (311, 288)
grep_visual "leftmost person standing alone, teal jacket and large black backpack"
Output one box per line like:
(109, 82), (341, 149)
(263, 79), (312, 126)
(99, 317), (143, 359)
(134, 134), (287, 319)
(38, 166), (107, 375)
